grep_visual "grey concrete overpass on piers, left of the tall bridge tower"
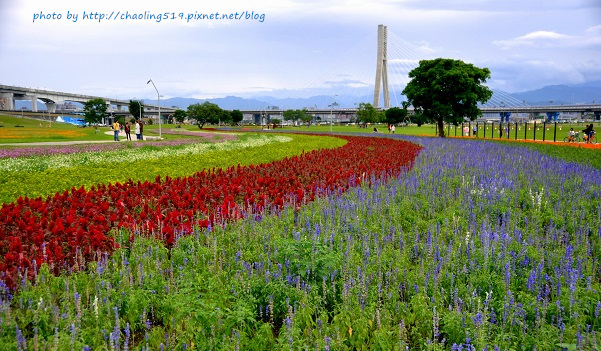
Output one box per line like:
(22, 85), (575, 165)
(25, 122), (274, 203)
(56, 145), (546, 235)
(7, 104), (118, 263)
(0, 85), (176, 114)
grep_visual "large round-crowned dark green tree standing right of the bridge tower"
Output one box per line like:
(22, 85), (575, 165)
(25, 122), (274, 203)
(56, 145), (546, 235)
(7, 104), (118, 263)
(403, 58), (492, 137)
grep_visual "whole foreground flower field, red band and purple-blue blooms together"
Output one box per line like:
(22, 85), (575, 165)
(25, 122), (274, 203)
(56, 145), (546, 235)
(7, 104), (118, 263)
(0, 133), (601, 350)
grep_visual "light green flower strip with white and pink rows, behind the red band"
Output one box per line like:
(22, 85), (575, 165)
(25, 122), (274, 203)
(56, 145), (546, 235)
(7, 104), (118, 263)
(0, 133), (346, 203)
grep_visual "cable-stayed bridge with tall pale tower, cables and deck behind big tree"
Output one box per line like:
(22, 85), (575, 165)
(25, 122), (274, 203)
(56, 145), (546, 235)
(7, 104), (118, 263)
(244, 25), (601, 124)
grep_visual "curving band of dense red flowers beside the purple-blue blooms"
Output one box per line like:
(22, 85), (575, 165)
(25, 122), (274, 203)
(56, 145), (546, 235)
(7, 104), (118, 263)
(0, 136), (421, 287)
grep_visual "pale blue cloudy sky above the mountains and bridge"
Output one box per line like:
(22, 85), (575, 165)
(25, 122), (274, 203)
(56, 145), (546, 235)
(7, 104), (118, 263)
(0, 0), (601, 103)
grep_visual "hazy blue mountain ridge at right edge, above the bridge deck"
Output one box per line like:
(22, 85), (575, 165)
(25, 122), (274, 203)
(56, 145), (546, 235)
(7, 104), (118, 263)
(511, 81), (601, 106)
